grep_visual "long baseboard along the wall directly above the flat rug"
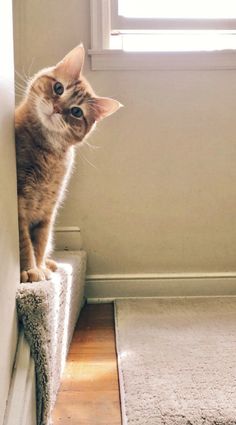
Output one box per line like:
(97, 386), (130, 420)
(85, 272), (236, 303)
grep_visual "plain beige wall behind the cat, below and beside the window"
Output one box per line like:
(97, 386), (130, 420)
(15, 0), (236, 274)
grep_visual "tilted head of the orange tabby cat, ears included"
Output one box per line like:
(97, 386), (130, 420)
(26, 45), (122, 143)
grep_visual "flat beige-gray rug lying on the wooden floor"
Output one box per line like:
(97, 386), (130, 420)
(115, 297), (236, 425)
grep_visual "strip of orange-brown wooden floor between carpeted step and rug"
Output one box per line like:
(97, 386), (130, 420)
(53, 304), (121, 425)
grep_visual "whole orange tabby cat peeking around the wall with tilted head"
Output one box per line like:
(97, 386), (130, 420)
(15, 44), (122, 282)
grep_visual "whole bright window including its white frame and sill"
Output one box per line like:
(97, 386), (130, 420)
(90, 0), (236, 69)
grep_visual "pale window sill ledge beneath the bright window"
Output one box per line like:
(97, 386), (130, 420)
(89, 50), (236, 71)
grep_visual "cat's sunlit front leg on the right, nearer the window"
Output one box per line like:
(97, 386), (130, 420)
(31, 220), (57, 279)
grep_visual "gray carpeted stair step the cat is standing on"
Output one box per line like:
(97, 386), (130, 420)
(17, 251), (86, 425)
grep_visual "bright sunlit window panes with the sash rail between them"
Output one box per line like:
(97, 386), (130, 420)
(110, 0), (236, 52)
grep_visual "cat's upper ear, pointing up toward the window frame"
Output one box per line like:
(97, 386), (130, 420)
(55, 44), (85, 80)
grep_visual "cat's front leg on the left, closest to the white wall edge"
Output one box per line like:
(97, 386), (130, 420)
(19, 216), (45, 283)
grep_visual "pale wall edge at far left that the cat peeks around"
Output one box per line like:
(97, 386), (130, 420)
(0, 0), (19, 424)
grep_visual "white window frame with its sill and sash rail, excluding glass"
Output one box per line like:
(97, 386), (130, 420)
(89, 0), (236, 70)
